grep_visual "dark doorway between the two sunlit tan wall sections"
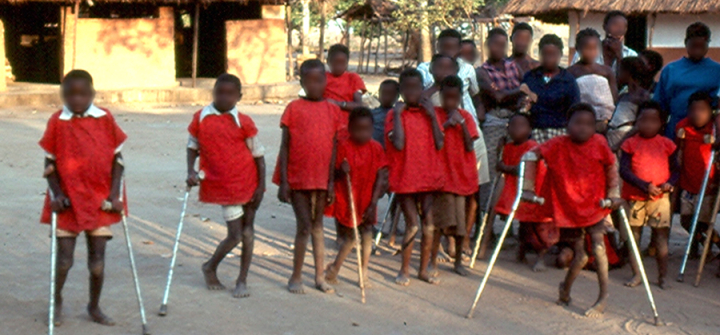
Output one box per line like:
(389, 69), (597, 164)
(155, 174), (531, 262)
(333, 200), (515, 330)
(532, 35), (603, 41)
(175, 1), (262, 78)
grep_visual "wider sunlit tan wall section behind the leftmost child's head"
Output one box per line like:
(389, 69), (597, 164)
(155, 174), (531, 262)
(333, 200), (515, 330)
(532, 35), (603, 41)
(63, 7), (177, 89)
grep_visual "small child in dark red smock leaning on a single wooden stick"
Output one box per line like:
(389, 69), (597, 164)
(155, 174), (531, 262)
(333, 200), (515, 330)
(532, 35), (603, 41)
(325, 107), (388, 287)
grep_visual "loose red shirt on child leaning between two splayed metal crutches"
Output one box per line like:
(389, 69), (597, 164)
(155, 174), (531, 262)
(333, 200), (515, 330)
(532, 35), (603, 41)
(537, 134), (615, 228)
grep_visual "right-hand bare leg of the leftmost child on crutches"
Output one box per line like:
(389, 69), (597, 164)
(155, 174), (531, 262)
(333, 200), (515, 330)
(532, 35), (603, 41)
(87, 236), (115, 326)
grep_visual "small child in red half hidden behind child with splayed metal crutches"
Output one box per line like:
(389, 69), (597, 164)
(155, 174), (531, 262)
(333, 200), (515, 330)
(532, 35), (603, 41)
(495, 114), (560, 272)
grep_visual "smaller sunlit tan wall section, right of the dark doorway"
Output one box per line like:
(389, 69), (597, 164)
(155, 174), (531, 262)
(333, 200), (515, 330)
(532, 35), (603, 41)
(225, 19), (287, 85)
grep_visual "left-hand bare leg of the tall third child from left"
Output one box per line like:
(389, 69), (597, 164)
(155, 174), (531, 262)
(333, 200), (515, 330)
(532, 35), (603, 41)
(288, 191), (312, 294)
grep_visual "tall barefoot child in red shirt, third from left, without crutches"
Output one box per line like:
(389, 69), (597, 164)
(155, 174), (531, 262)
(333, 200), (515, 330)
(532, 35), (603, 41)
(273, 59), (342, 294)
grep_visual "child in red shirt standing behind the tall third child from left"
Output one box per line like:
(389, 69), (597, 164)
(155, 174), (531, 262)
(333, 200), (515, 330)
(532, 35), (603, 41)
(323, 44), (367, 126)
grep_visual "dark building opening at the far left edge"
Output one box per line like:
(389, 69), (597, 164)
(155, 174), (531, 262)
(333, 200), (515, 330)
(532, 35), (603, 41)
(0, 2), (63, 83)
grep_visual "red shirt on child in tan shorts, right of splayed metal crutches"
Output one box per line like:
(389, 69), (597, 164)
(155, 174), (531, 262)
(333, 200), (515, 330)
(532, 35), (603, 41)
(620, 135), (676, 201)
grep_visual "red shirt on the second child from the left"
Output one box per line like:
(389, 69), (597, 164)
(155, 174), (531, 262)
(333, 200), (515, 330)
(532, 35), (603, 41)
(188, 110), (258, 205)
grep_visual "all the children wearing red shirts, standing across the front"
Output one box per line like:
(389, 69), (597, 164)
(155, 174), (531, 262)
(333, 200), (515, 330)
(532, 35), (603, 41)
(40, 27), (715, 325)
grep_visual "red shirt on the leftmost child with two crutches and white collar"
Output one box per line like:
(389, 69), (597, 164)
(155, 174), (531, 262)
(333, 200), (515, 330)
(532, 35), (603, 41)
(40, 109), (127, 233)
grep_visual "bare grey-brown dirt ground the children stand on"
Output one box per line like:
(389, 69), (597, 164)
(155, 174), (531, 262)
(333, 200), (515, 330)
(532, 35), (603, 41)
(0, 105), (720, 334)
